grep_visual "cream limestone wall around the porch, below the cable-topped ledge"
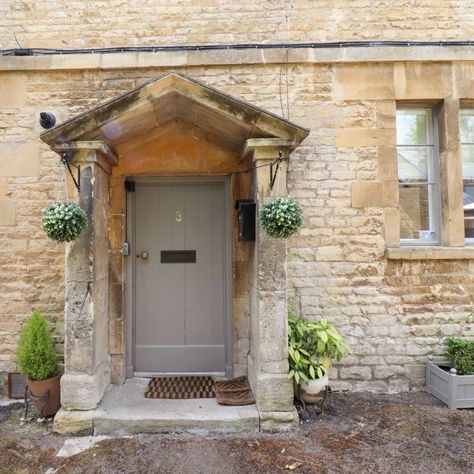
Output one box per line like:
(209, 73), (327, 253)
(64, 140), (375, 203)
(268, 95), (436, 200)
(0, 56), (474, 391)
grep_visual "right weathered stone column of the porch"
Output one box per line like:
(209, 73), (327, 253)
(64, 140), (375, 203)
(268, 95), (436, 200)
(245, 139), (298, 431)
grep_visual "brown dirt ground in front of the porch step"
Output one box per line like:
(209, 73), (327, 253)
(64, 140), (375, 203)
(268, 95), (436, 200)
(0, 393), (474, 474)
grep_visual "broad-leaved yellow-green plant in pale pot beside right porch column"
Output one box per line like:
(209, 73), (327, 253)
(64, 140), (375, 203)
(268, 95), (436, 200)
(288, 315), (350, 403)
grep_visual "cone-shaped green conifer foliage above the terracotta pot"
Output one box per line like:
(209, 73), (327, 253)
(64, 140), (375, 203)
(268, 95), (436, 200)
(16, 311), (59, 380)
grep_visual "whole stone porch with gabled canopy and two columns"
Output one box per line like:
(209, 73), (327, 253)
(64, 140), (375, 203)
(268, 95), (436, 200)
(40, 73), (309, 429)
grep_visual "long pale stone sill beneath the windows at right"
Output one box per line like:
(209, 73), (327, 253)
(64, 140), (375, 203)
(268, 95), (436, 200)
(385, 246), (474, 260)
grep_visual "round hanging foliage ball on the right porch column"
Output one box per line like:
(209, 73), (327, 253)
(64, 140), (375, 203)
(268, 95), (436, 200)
(259, 196), (303, 239)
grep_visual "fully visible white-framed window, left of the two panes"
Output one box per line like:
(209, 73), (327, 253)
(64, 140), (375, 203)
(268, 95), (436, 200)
(396, 108), (440, 245)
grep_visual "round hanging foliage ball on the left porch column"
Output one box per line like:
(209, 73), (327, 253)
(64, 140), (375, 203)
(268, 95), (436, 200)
(43, 202), (87, 242)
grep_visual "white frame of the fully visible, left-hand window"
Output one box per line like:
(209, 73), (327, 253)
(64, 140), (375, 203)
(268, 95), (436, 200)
(396, 104), (442, 247)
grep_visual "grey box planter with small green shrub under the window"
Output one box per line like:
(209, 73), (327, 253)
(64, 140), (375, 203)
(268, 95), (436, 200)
(426, 337), (474, 408)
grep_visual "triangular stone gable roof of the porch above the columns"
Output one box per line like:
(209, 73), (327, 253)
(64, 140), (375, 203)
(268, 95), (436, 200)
(41, 73), (309, 157)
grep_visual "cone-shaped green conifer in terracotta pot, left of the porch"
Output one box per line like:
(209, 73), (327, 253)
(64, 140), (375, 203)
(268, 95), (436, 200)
(16, 311), (61, 417)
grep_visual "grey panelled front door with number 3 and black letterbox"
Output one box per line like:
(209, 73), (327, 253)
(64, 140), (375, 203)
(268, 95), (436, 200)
(133, 182), (230, 373)
